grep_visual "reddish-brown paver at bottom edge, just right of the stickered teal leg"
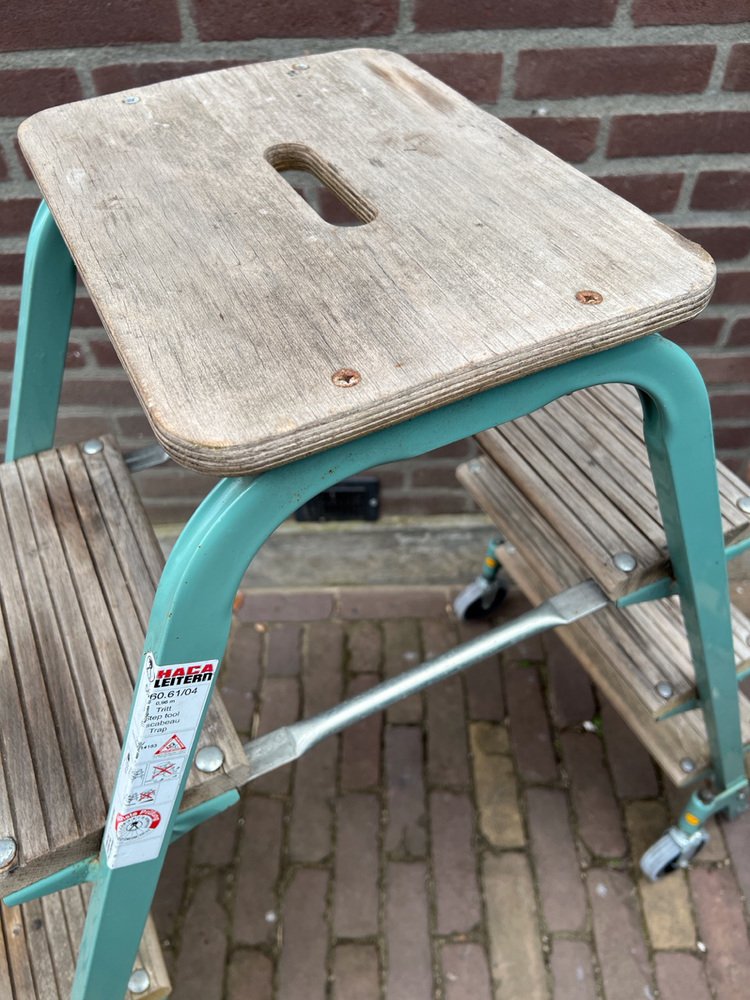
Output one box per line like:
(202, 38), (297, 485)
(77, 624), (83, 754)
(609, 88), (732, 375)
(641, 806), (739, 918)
(172, 873), (228, 1000)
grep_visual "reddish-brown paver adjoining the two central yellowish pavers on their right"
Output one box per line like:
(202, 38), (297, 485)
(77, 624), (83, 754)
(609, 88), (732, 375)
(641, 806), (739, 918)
(526, 788), (587, 932)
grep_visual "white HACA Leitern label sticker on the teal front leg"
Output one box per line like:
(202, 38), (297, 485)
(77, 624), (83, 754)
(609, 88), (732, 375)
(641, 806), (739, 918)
(104, 653), (219, 868)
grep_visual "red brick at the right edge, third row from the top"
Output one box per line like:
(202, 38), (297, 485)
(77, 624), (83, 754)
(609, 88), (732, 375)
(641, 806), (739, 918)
(607, 111), (750, 157)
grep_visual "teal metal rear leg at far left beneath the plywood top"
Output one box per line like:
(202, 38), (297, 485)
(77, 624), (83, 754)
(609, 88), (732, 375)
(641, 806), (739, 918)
(5, 202), (76, 462)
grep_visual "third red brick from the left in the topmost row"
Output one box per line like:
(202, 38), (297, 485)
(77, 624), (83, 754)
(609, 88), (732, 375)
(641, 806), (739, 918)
(414, 0), (617, 31)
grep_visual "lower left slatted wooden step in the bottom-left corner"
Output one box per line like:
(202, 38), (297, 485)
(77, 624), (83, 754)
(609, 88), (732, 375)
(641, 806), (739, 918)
(0, 886), (171, 1000)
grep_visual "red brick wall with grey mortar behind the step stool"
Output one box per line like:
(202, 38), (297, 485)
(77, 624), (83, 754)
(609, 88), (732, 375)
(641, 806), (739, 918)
(0, 0), (750, 521)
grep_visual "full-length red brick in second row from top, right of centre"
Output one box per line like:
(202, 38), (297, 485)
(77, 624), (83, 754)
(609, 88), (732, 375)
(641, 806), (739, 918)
(515, 45), (716, 98)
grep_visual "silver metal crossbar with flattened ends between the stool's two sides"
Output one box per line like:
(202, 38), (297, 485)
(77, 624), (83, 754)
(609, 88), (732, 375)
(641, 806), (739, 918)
(245, 580), (609, 781)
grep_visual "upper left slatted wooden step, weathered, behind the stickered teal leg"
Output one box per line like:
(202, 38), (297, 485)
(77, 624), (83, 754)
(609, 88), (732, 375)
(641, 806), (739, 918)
(0, 439), (247, 896)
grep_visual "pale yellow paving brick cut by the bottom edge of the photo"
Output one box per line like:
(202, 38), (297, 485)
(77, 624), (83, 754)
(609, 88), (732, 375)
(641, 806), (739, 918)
(482, 853), (547, 1000)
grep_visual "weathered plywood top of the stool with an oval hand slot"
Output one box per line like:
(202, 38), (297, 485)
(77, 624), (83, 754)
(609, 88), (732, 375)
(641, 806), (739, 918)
(20, 50), (714, 475)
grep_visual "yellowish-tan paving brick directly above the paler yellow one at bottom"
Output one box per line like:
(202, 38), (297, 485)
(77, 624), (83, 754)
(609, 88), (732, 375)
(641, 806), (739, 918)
(469, 722), (526, 847)
